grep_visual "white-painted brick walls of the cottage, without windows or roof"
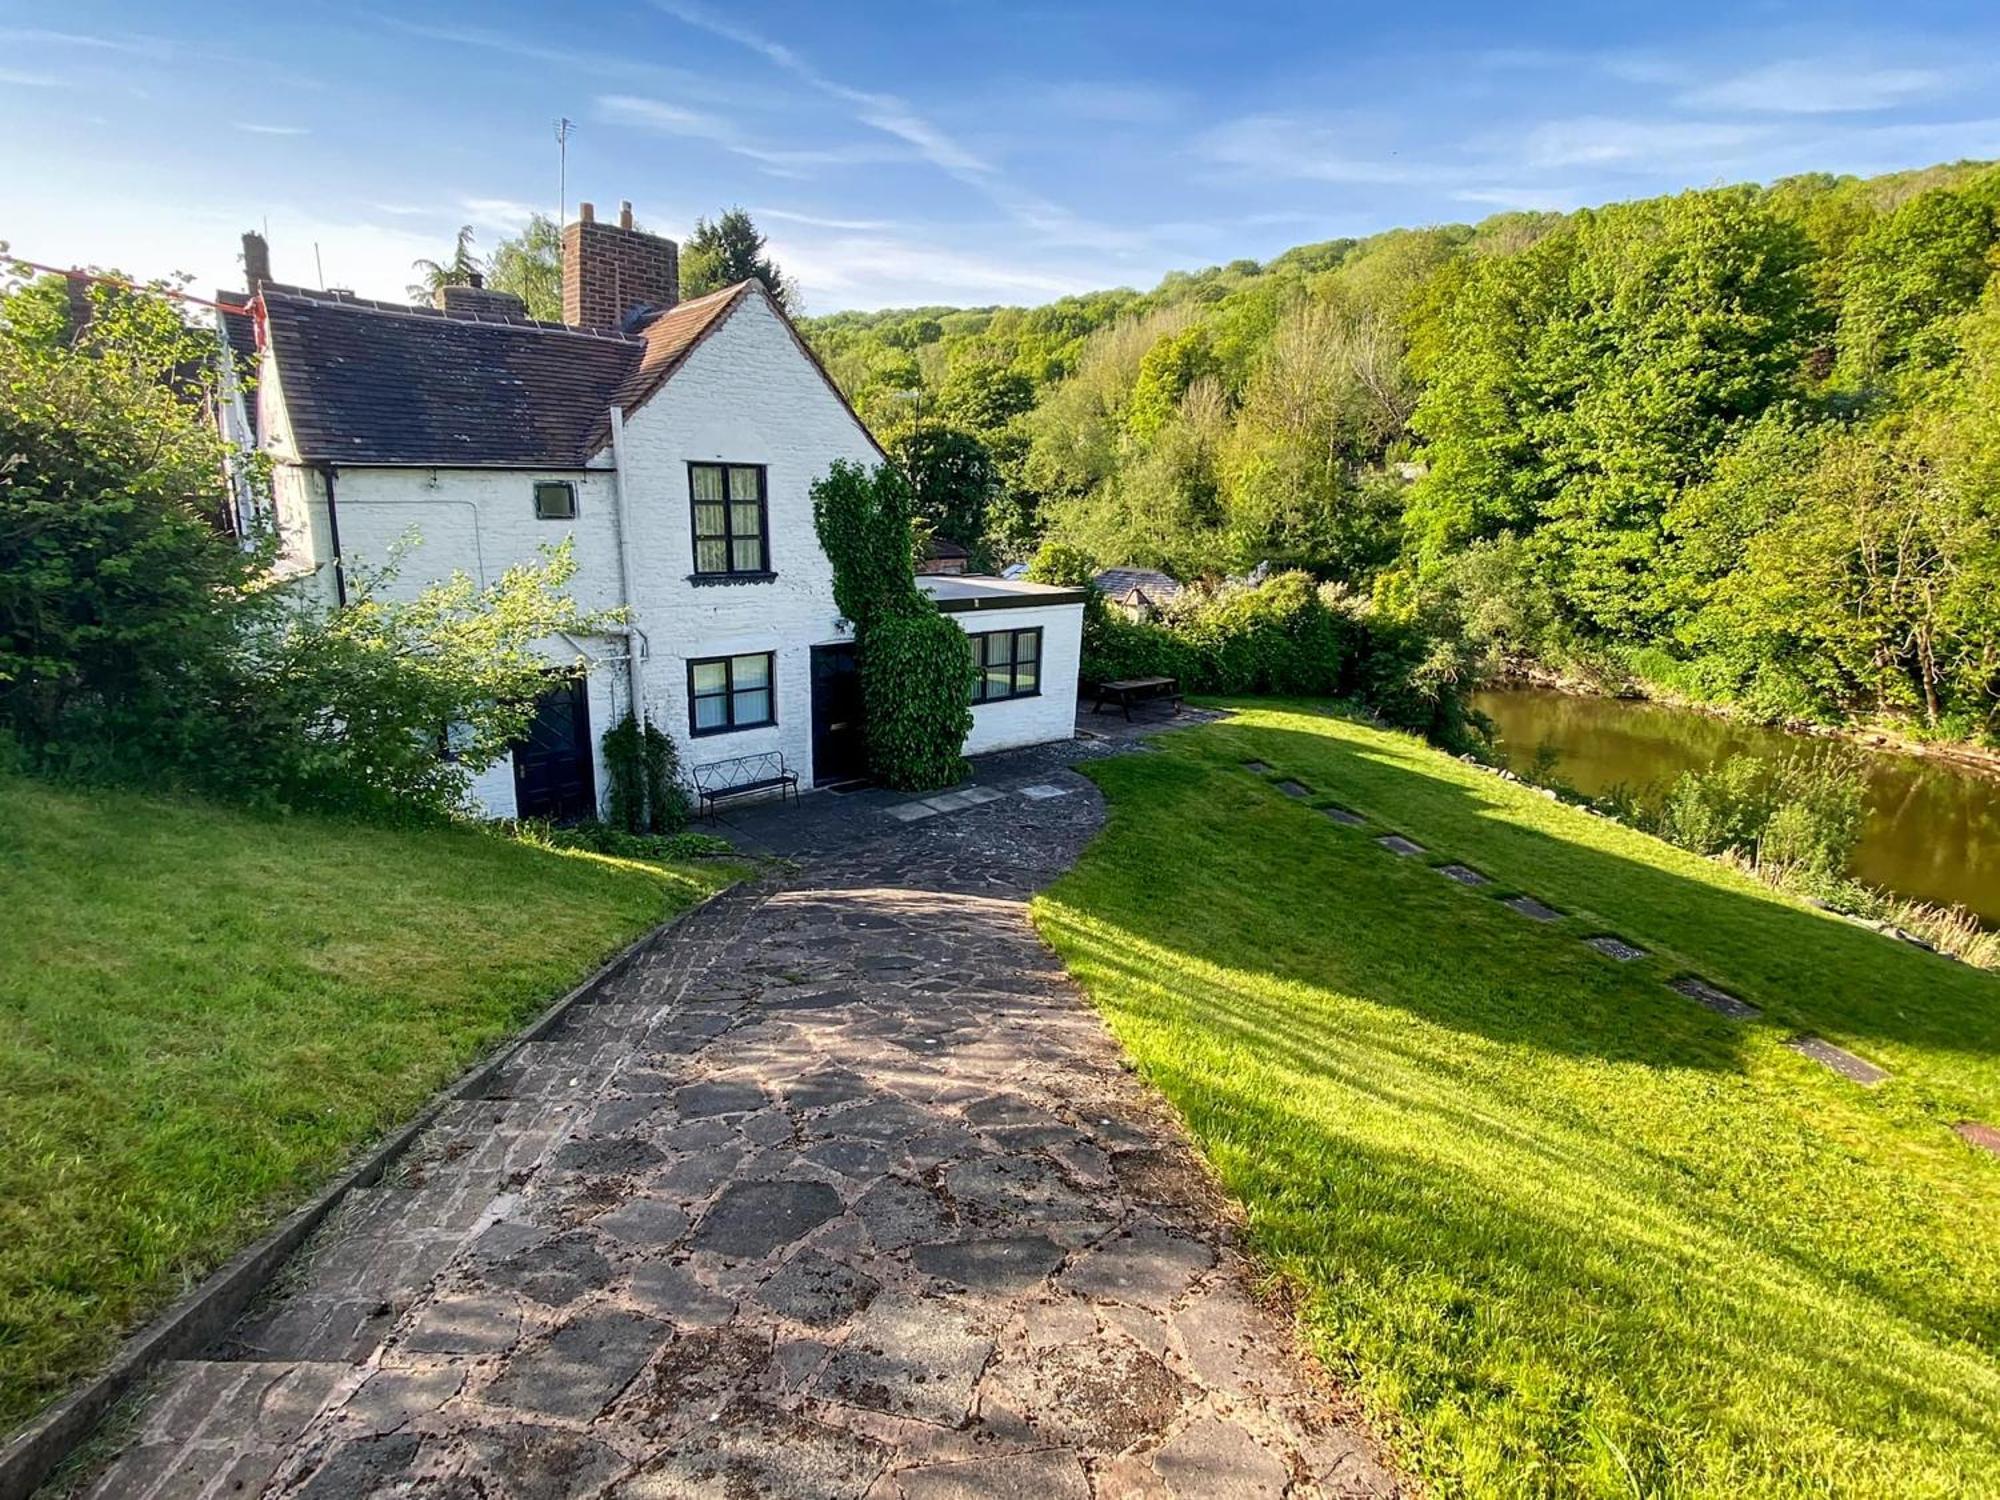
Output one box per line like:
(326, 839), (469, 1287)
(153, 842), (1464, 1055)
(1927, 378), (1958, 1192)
(262, 286), (1082, 818)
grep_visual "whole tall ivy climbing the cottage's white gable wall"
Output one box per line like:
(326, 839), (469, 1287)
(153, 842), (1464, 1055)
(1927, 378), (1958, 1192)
(812, 462), (974, 792)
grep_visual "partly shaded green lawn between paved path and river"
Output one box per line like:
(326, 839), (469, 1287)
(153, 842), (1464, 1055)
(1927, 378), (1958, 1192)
(1036, 704), (2000, 1496)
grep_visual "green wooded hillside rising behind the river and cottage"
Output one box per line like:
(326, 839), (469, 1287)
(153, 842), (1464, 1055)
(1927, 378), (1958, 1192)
(810, 164), (2000, 738)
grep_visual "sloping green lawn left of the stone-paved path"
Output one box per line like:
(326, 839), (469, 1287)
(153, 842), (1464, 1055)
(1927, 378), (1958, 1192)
(0, 776), (736, 1430)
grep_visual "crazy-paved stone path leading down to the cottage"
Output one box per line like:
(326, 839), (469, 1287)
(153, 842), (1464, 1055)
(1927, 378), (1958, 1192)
(78, 742), (1398, 1500)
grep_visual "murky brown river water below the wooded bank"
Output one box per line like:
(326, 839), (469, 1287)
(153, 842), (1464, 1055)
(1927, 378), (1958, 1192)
(1472, 688), (2000, 926)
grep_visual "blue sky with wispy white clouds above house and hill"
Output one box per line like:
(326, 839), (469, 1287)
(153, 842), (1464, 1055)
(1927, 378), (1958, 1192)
(0, 0), (2000, 312)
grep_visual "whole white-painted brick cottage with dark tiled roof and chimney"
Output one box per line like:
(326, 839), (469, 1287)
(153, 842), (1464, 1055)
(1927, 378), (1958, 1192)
(224, 204), (1082, 818)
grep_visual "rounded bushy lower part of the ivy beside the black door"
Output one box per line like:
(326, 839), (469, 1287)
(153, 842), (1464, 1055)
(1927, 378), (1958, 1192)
(860, 610), (976, 792)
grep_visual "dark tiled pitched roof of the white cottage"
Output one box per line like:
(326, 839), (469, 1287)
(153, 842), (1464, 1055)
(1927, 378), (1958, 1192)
(264, 282), (838, 468)
